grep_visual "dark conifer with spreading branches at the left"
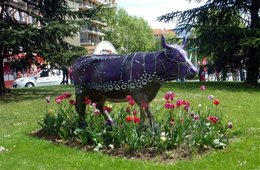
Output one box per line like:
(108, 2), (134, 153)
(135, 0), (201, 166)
(0, 0), (102, 95)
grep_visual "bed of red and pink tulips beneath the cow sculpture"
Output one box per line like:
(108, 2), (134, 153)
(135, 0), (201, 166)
(39, 86), (233, 151)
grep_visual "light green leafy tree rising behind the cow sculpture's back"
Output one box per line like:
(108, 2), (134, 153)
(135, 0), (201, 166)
(104, 9), (154, 53)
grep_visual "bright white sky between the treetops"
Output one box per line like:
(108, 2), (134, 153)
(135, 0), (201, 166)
(117, 0), (205, 29)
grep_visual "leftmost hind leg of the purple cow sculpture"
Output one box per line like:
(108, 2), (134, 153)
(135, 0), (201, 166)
(76, 93), (86, 128)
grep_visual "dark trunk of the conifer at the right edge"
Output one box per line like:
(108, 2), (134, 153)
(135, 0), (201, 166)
(246, 0), (260, 84)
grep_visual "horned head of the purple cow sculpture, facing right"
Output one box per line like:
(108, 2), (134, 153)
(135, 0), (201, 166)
(162, 35), (196, 79)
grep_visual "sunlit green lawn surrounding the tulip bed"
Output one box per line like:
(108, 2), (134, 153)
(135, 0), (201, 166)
(0, 82), (260, 170)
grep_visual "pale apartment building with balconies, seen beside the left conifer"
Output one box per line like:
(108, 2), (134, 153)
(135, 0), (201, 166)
(66, 0), (116, 54)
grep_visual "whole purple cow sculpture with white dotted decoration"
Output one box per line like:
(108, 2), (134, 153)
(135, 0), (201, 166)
(73, 36), (196, 128)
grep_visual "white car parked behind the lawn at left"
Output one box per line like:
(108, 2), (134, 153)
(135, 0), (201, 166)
(13, 69), (63, 87)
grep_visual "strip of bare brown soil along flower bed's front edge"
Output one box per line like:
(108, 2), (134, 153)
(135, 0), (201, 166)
(32, 130), (210, 163)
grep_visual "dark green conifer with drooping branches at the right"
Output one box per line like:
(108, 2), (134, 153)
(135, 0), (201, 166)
(159, 0), (260, 84)
